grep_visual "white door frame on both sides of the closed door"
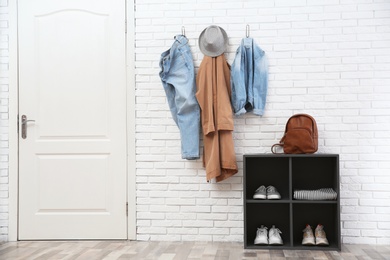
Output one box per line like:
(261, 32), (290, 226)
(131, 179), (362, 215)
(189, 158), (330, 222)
(8, 0), (137, 241)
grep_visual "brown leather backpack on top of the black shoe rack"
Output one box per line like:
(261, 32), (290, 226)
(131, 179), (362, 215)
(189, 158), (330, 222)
(271, 114), (318, 154)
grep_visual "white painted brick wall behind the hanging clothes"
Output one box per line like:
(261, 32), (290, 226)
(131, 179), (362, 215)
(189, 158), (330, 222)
(0, 0), (390, 244)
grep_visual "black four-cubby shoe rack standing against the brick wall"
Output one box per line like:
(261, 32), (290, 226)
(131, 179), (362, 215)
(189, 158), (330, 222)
(244, 154), (341, 251)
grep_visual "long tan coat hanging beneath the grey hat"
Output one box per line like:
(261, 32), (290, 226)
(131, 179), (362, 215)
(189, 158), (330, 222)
(196, 54), (238, 182)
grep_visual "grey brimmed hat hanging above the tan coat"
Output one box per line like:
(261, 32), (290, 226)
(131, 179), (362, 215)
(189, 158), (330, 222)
(199, 25), (228, 57)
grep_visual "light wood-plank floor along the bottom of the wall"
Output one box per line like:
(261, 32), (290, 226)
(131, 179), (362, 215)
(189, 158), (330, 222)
(0, 241), (390, 260)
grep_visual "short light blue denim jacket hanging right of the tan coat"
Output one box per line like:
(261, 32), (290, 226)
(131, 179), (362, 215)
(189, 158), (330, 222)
(230, 38), (268, 116)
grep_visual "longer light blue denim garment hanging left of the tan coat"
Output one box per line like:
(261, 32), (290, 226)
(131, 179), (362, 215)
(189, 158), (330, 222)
(160, 35), (200, 160)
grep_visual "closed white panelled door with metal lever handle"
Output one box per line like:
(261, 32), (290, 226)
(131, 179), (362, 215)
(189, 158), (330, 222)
(18, 0), (127, 240)
